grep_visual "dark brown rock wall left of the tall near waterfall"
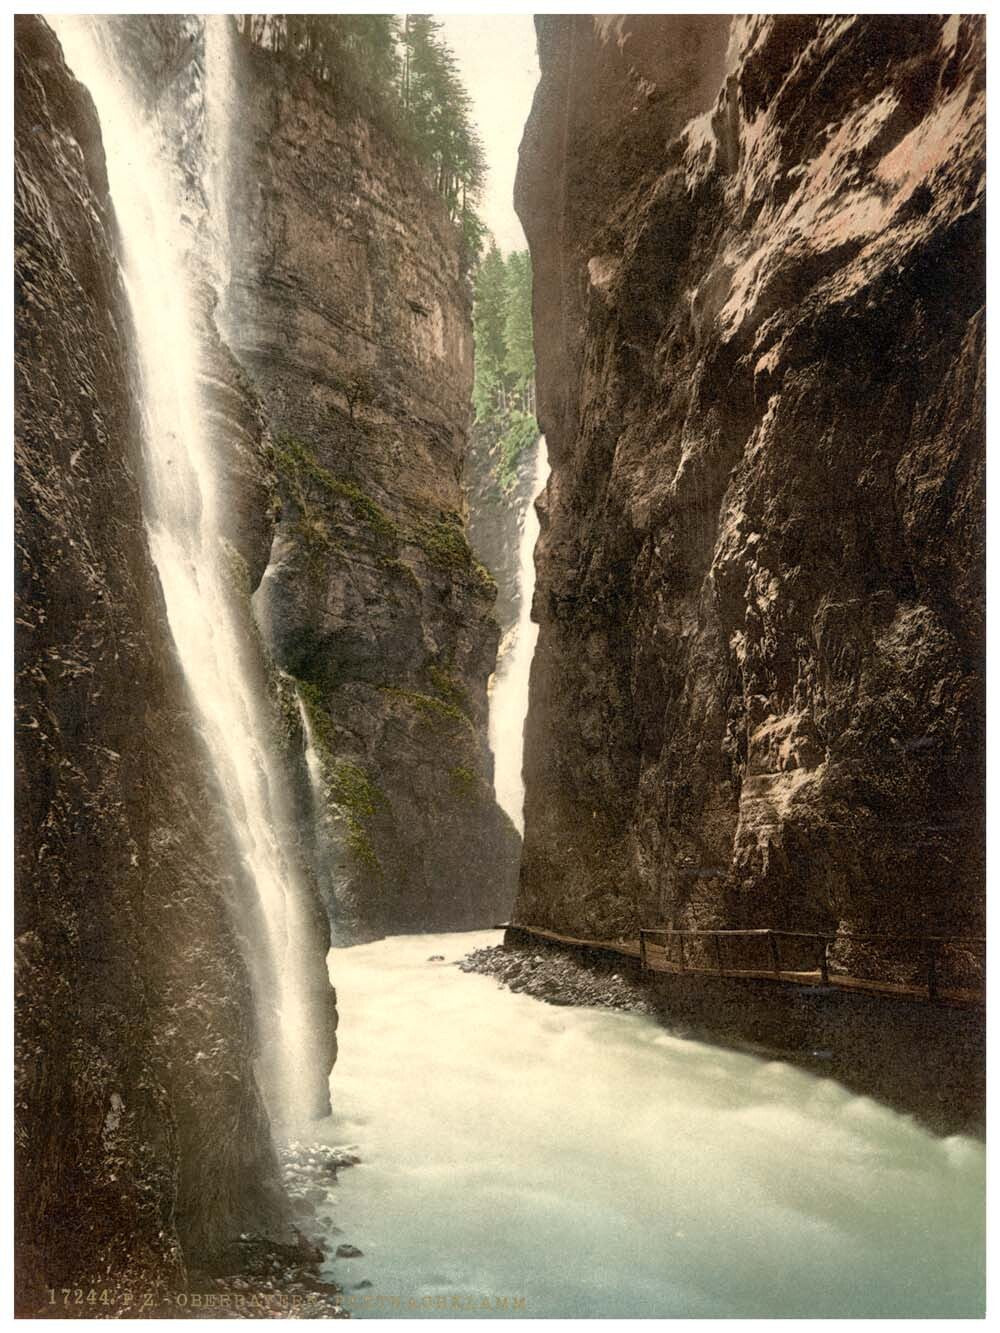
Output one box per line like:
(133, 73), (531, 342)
(15, 17), (293, 1313)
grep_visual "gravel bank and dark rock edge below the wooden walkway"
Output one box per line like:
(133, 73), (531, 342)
(460, 926), (985, 1137)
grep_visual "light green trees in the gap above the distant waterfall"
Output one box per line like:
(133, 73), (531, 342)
(472, 243), (539, 491)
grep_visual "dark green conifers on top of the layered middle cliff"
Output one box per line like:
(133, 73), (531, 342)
(236, 13), (485, 263)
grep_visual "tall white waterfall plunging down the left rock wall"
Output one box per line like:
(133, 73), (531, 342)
(52, 15), (323, 1125)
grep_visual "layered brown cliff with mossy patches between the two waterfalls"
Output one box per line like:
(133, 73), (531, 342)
(220, 41), (520, 944)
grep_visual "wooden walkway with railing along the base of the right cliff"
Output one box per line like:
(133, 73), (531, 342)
(512, 922), (985, 1005)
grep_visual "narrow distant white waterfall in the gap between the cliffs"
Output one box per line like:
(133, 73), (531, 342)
(489, 436), (548, 833)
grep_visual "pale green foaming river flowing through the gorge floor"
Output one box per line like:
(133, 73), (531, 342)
(312, 933), (984, 1318)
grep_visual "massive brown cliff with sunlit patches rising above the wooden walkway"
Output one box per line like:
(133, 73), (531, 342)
(516, 16), (984, 936)
